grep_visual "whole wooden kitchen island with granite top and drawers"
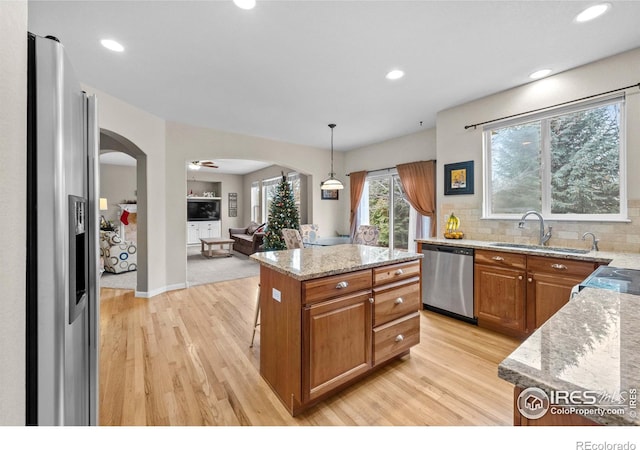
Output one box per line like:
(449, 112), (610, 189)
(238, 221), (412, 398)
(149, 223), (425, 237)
(251, 244), (422, 415)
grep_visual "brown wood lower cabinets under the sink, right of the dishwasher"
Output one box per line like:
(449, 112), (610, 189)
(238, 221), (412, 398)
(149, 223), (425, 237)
(474, 250), (596, 338)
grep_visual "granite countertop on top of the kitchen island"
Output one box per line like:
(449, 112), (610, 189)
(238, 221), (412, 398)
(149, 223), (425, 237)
(251, 244), (423, 281)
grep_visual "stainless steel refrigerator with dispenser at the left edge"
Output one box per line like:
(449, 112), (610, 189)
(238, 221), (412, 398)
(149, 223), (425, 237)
(25, 33), (99, 425)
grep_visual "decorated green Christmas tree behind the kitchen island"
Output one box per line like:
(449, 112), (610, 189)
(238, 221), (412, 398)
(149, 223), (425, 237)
(264, 174), (300, 250)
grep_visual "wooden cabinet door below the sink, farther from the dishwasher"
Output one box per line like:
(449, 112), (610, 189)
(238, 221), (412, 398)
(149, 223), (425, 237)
(527, 272), (584, 333)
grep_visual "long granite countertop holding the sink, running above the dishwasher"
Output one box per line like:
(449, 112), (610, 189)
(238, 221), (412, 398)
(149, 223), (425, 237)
(416, 238), (640, 269)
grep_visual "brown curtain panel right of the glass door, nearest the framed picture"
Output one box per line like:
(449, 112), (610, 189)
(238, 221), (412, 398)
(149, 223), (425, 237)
(398, 161), (436, 236)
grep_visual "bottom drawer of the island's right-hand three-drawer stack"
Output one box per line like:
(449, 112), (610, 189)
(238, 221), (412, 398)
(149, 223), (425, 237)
(373, 311), (420, 365)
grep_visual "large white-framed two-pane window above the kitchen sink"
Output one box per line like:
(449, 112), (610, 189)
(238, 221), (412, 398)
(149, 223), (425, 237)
(483, 96), (627, 220)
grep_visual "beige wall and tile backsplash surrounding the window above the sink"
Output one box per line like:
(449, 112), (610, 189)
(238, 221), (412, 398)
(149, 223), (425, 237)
(436, 49), (640, 252)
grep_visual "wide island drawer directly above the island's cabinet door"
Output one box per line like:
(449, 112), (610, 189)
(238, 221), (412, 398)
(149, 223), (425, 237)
(302, 269), (371, 305)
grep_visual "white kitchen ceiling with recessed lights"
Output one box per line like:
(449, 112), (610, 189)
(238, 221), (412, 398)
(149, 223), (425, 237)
(29, 0), (640, 151)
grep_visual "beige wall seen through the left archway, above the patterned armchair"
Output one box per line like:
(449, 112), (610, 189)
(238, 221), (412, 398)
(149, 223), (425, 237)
(100, 164), (137, 226)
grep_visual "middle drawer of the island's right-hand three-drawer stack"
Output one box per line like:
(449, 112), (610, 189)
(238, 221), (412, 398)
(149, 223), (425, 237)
(373, 277), (422, 327)
